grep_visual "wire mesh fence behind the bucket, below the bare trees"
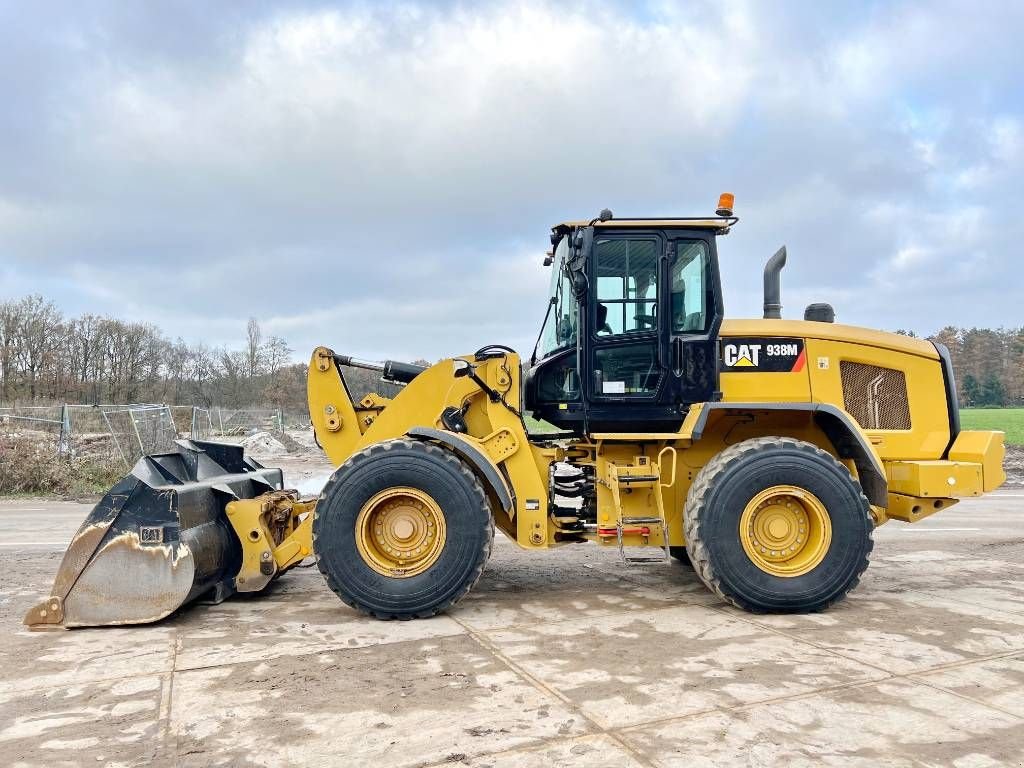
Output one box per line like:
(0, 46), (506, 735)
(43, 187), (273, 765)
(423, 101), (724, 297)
(0, 403), (288, 468)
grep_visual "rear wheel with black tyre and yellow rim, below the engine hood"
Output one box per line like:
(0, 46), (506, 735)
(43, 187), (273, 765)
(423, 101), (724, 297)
(684, 437), (874, 612)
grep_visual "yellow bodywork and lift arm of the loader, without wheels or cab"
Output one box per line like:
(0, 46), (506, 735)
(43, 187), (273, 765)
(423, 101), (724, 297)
(308, 321), (1006, 561)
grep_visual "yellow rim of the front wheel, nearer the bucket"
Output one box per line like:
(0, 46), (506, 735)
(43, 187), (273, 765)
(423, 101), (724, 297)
(355, 485), (446, 579)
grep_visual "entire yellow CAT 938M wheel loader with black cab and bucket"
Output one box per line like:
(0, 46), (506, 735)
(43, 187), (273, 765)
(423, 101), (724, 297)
(26, 195), (1005, 627)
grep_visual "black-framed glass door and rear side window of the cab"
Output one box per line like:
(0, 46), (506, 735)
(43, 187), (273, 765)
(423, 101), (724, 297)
(580, 229), (723, 432)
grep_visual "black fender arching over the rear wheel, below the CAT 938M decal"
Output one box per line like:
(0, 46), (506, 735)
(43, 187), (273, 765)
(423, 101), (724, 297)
(690, 402), (889, 509)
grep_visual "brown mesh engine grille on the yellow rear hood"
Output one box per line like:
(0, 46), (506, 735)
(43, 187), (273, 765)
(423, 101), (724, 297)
(839, 360), (910, 429)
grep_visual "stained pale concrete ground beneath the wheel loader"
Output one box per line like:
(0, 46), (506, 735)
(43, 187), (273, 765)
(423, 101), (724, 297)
(0, 481), (1024, 768)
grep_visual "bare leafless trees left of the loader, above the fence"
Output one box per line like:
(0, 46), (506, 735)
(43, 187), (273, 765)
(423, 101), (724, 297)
(0, 295), (306, 410)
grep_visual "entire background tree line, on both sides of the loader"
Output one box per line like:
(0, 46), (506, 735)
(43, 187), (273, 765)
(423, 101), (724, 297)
(0, 295), (1024, 412)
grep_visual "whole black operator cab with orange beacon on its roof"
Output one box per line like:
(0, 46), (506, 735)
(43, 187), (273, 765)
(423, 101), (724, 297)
(524, 196), (737, 433)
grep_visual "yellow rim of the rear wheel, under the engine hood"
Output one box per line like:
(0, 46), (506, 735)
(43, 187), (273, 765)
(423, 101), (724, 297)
(739, 485), (831, 578)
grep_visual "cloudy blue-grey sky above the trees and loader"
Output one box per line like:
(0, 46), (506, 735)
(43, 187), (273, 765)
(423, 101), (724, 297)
(0, 0), (1024, 359)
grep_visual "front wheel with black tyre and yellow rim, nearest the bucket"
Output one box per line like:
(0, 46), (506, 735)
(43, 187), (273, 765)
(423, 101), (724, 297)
(312, 439), (495, 620)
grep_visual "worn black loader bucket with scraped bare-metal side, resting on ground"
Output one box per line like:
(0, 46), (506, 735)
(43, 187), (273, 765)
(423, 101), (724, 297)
(25, 440), (284, 628)
